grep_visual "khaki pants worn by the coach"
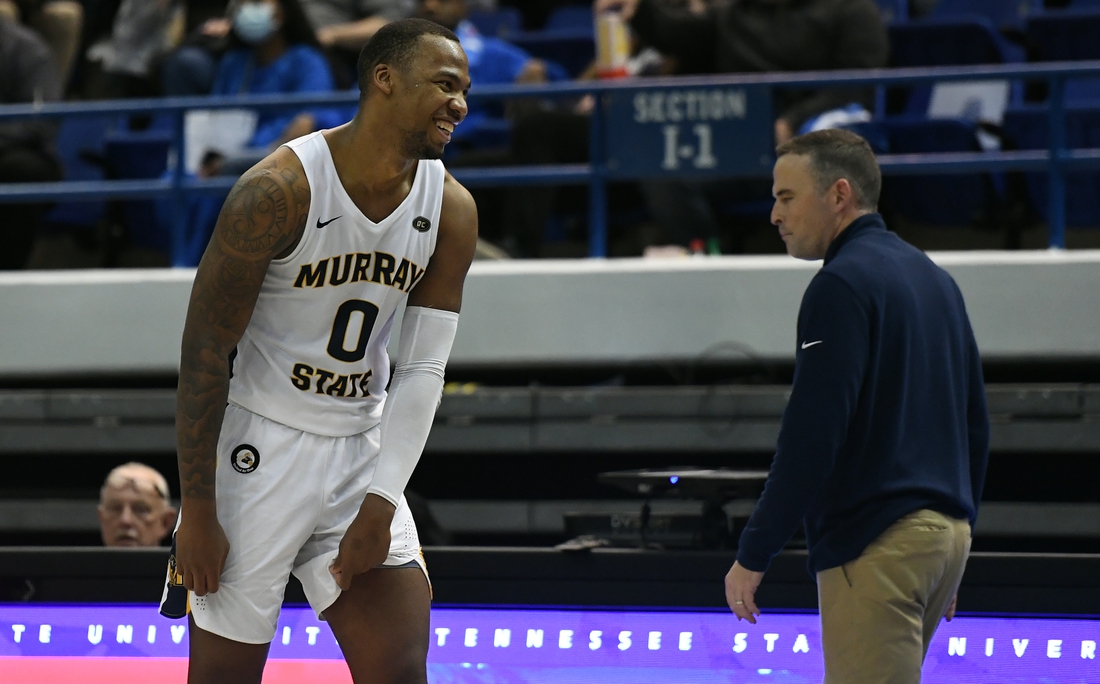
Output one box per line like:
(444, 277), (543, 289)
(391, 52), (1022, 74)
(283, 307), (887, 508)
(817, 510), (970, 684)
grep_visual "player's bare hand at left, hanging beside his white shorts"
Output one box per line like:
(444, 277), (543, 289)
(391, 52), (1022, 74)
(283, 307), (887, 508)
(176, 499), (229, 596)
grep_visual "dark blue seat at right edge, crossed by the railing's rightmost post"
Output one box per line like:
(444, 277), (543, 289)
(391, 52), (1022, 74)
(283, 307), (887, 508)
(1003, 106), (1100, 228)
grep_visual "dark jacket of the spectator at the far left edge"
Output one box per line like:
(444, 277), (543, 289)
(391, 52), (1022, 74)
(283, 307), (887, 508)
(0, 19), (62, 151)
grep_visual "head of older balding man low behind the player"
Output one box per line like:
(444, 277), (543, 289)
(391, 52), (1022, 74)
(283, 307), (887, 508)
(99, 463), (176, 547)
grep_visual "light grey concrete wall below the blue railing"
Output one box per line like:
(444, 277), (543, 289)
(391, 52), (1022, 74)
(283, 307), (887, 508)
(0, 251), (1100, 377)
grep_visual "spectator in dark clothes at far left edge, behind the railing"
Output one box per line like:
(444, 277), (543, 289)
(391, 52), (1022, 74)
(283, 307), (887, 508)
(0, 18), (62, 269)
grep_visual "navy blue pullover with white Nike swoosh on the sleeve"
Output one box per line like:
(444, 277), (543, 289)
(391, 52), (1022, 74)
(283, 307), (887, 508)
(737, 213), (989, 573)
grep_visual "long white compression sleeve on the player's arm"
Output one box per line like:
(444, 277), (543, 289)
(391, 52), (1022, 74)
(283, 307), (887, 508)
(366, 307), (459, 506)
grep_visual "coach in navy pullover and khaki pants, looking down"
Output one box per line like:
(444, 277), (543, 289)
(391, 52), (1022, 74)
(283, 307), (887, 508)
(726, 130), (989, 684)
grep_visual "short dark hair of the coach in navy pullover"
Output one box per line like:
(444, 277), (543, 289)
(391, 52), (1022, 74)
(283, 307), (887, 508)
(776, 129), (882, 211)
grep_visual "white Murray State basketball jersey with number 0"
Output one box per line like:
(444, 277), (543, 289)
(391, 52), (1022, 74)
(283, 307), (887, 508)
(229, 132), (446, 437)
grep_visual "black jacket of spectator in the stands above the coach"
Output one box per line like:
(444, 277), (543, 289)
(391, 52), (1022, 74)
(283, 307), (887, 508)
(631, 0), (889, 131)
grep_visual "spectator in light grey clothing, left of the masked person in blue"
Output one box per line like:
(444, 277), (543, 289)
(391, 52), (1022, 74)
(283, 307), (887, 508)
(84, 0), (185, 99)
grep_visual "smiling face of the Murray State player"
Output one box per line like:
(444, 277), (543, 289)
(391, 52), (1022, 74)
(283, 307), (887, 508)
(400, 35), (470, 159)
